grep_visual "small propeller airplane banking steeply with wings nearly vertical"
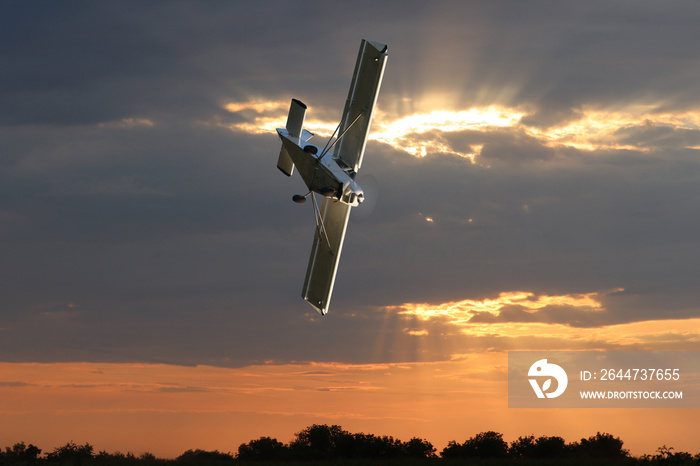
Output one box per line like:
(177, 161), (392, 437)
(277, 39), (388, 315)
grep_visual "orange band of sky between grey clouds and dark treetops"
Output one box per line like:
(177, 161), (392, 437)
(0, 354), (698, 459)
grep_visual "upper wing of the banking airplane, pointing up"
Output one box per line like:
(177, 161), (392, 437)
(333, 39), (387, 172)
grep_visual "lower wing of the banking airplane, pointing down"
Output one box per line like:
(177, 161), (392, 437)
(301, 194), (351, 314)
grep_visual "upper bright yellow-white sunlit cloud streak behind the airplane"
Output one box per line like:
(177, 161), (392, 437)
(224, 99), (700, 158)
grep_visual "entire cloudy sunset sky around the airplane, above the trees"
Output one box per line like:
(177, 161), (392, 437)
(0, 0), (700, 457)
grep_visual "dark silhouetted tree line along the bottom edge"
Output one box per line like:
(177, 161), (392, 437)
(0, 424), (700, 466)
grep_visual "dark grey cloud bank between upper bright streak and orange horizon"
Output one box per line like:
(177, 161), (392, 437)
(3, 115), (697, 365)
